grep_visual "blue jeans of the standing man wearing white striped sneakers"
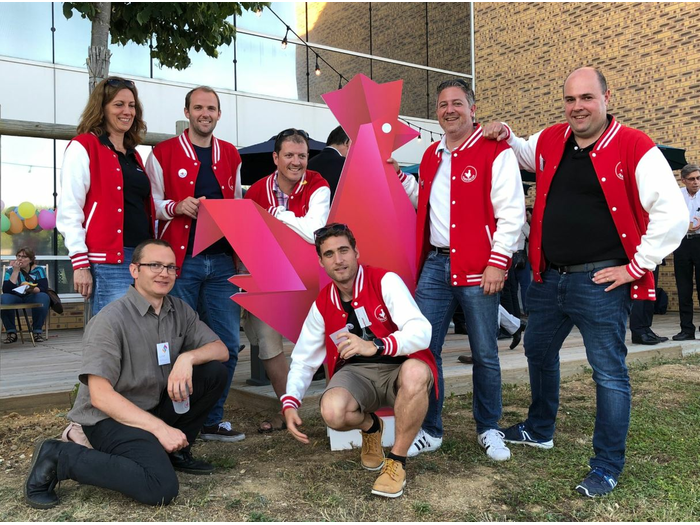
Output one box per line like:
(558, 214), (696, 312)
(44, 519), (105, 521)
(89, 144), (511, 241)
(416, 253), (501, 437)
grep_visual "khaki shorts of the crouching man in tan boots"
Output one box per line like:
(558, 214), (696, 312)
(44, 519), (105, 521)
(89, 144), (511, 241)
(321, 361), (433, 413)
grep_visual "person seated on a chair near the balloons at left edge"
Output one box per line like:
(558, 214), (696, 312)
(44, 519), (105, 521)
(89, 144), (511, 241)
(0, 246), (51, 345)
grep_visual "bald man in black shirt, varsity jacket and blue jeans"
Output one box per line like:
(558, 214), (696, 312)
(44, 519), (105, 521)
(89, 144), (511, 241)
(484, 67), (698, 497)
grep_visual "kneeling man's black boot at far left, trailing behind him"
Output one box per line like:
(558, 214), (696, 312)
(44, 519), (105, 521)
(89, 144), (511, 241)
(24, 439), (62, 509)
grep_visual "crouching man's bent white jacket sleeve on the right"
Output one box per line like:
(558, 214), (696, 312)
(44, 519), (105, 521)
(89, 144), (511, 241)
(382, 272), (433, 356)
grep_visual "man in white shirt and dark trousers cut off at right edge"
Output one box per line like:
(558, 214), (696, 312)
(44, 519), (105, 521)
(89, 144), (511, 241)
(673, 164), (700, 341)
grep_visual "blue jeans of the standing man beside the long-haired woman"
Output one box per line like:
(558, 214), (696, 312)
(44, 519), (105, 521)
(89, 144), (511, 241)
(170, 253), (241, 426)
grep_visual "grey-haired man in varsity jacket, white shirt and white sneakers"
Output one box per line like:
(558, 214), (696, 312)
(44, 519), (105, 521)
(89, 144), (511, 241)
(389, 79), (525, 461)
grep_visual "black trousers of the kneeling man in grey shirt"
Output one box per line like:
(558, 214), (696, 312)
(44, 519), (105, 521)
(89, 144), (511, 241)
(57, 361), (228, 505)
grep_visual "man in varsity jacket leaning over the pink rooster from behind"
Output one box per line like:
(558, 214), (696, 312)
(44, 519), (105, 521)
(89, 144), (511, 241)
(245, 128), (331, 433)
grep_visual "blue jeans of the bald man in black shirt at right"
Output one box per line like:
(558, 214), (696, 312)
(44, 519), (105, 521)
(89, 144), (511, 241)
(524, 270), (632, 476)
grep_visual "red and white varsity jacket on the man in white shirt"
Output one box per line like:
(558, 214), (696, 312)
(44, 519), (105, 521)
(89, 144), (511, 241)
(399, 125), (525, 286)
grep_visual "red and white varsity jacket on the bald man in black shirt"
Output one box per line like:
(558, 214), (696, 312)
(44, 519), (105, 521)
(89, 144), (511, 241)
(507, 118), (688, 300)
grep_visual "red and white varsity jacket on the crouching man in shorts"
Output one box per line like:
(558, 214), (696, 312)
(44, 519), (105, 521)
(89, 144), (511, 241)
(280, 266), (437, 410)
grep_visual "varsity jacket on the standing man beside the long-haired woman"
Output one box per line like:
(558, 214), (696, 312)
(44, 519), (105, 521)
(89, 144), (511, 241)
(146, 129), (242, 266)
